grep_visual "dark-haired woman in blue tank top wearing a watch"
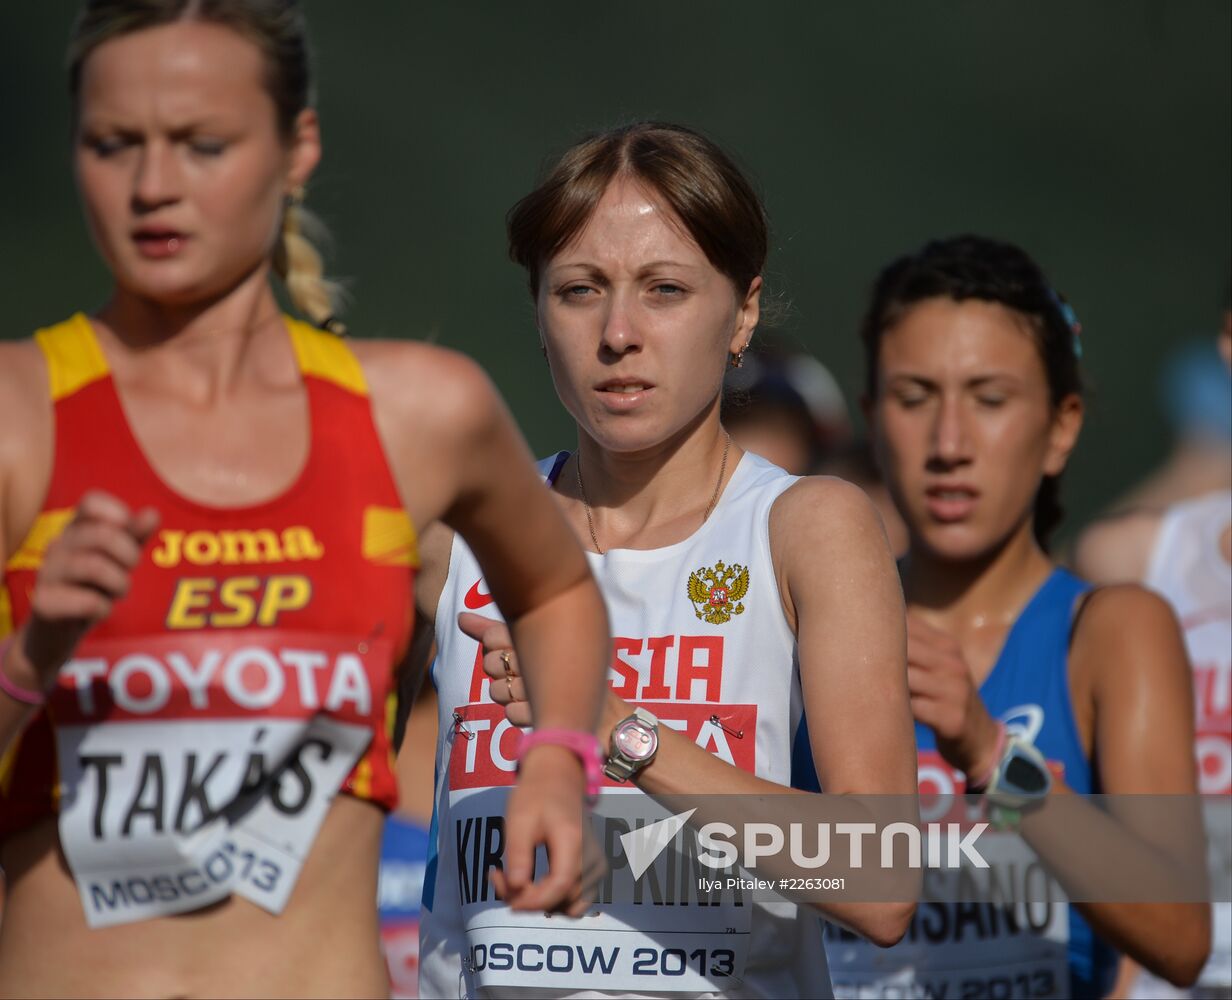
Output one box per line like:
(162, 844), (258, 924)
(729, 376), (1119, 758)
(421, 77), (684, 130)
(828, 236), (1209, 996)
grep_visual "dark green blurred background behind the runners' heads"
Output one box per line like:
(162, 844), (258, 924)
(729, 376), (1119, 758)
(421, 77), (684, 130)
(0, 0), (1232, 528)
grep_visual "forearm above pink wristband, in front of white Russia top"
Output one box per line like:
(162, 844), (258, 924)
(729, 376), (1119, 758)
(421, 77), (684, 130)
(507, 575), (611, 730)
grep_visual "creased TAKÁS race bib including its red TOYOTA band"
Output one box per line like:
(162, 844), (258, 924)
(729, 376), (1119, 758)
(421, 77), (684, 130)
(49, 632), (391, 927)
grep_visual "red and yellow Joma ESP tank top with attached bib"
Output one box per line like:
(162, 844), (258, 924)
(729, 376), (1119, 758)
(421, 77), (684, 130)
(0, 314), (418, 926)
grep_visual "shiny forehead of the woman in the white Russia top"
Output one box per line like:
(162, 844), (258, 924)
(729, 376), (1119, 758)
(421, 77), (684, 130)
(551, 177), (708, 267)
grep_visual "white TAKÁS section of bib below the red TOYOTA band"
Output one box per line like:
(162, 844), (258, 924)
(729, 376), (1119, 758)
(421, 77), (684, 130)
(57, 717), (372, 927)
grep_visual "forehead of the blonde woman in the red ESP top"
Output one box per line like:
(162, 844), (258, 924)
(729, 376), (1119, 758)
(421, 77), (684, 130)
(80, 21), (269, 126)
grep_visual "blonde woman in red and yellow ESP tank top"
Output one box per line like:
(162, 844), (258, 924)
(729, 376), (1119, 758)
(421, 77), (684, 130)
(0, 0), (607, 996)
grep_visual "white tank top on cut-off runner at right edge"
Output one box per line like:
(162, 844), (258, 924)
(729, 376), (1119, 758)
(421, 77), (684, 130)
(1136, 490), (1232, 995)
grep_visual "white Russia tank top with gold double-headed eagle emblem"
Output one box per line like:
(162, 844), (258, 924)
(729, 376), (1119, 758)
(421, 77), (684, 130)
(419, 453), (832, 996)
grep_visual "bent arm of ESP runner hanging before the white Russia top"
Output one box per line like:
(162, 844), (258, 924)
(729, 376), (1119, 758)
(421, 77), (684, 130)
(426, 362), (610, 916)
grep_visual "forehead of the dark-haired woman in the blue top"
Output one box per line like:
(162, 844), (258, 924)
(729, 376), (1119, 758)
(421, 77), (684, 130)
(880, 298), (1044, 377)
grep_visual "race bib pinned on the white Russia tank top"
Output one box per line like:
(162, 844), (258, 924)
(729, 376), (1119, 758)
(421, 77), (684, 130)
(442, 702), (756, 993)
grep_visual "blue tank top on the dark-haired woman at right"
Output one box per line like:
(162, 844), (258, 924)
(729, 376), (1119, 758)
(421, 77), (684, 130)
(915, 569), (1117, 998)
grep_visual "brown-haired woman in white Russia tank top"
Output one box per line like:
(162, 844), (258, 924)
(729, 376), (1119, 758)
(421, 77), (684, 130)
(420, 123), (914, 996)
